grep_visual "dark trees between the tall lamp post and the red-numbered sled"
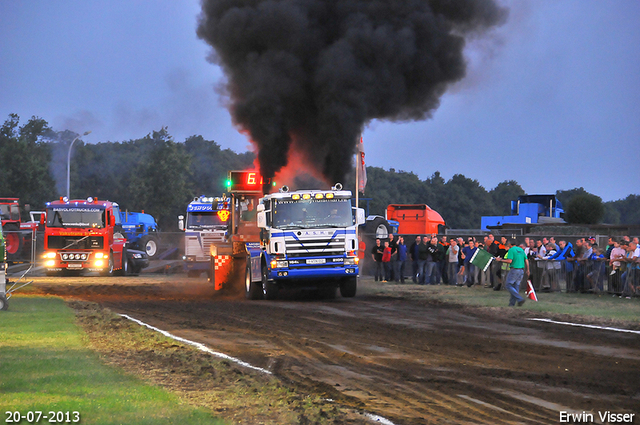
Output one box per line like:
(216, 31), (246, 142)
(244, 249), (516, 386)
(71, 128), (254, 230)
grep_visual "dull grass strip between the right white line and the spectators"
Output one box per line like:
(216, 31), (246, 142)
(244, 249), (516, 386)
(359, 278), (640, 329)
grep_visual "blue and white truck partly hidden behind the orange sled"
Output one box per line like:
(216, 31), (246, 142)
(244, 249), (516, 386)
(178, 195), (229, 277)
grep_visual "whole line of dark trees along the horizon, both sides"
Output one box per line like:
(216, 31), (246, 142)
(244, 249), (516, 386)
(0, 114), (640, 231)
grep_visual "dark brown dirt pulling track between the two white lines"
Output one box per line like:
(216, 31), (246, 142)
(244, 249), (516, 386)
(35, 275), (640, 424)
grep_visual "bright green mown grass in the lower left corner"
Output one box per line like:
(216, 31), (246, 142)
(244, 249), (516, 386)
(0, 297), (223, 424)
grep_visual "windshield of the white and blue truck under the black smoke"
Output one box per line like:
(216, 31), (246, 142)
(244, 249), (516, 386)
(272, 199), (353, 229)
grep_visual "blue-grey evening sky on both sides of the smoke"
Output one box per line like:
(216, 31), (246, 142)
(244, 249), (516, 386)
(0, 0), (640, 203)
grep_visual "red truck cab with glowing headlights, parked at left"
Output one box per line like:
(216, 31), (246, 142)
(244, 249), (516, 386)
(44, 197), (128, 276)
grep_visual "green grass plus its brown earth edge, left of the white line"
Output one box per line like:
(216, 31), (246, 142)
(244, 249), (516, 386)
(0, 294), (362, 425)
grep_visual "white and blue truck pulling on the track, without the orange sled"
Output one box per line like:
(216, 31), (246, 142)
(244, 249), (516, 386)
(251, 184), (364, 299)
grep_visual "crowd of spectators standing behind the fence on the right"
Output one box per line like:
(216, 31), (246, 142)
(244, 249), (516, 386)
(371, 234), (640, 298)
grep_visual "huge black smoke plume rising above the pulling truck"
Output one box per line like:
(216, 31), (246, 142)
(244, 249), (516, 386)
(197, 0), (507, 182)
